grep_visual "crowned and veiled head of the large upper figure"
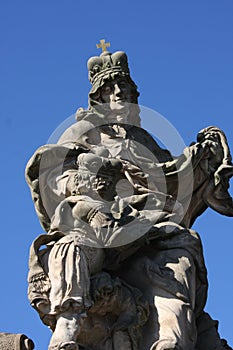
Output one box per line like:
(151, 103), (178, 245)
(87, 51), (139, 125)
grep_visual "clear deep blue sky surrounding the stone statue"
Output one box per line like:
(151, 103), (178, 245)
(0, 0), (233, 350)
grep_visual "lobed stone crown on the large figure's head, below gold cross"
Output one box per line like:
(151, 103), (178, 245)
(87, 51), (130, 86)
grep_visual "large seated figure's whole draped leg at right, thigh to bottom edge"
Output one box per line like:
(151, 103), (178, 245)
(116, 229), (207, 350)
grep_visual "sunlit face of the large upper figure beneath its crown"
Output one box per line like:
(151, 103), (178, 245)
(100, 78), (131, 116)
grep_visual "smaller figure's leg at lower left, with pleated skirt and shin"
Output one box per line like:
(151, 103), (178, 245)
(48, 240), (102, 350)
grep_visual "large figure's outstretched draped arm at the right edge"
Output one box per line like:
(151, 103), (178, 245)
(163, 126), (233, 227)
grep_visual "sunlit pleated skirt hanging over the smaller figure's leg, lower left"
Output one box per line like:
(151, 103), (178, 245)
(48, 238), (91, 315)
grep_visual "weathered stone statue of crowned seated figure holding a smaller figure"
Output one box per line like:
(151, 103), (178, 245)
(26, 41), (233, 350)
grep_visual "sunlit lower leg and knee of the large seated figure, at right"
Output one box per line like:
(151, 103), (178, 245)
(148, 249), (197, 350)
